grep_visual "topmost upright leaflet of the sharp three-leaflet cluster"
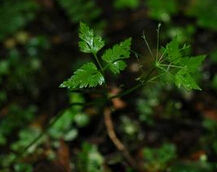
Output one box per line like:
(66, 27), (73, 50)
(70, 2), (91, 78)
(79, 23), (105, 54)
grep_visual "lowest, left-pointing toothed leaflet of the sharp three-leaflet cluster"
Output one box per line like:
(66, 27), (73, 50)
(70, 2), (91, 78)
(60, 63), (105, 89)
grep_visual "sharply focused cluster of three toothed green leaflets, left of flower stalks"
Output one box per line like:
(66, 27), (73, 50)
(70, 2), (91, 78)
(61, 23), (131, 89)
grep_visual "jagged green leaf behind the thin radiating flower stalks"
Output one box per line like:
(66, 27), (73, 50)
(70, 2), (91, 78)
(156, 38), (206, 90)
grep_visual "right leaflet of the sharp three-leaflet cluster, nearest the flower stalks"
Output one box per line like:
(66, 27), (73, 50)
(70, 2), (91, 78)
(102, 38), (131, 74)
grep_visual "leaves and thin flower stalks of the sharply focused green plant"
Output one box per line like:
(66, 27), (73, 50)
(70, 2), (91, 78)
(60, 23), (205, 90)
